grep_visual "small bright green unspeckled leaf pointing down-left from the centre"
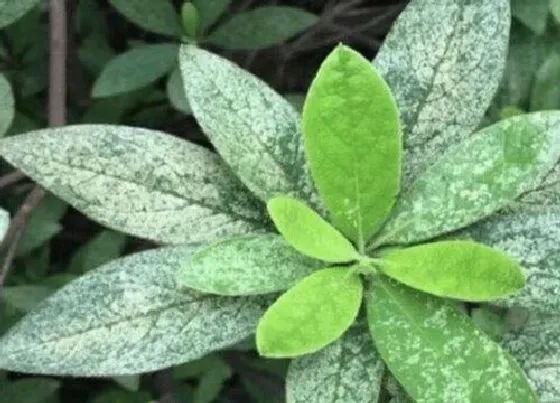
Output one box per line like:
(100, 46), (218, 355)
(257, 267), (362, 358)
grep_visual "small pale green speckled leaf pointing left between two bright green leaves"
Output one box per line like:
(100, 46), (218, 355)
(178, 234), (320, 296)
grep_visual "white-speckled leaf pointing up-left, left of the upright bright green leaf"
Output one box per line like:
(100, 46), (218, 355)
(179, 45), (312, 205)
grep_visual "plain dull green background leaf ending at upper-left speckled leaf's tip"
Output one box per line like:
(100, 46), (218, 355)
(92, 43), (178, 98)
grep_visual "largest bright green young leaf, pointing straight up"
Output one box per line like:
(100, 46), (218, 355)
(303, 45), (401, 246)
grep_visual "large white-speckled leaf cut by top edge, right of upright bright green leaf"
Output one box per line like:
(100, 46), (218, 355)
(375, 0), (510, 188)
